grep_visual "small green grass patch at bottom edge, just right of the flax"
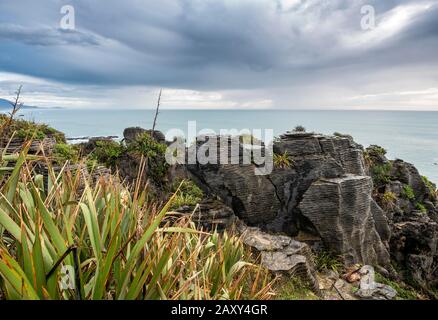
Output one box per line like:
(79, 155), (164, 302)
(275, 276), (320, 300)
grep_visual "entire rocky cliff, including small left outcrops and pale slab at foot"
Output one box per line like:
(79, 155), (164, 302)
(46, 128), (438, 298)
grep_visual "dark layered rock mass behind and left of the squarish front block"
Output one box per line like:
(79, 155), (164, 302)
(187, 134), (354, 231)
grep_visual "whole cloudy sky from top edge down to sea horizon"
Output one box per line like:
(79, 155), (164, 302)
(0, 0), (438, 110)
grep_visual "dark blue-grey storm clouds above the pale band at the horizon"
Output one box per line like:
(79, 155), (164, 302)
(0, 0), (438, 109)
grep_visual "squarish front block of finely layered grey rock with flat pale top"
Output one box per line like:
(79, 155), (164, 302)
(299, 175), (389, 265)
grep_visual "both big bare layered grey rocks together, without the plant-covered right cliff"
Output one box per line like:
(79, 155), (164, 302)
(187, 133), (390, 265)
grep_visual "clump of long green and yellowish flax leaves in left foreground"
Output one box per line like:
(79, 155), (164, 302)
(0, 151), (271, 300)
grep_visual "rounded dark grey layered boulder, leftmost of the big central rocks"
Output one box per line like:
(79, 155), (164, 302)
(187, 137), (281, 225)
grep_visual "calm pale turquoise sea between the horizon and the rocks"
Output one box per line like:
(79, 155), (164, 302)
(18, 109), (438, 182)
